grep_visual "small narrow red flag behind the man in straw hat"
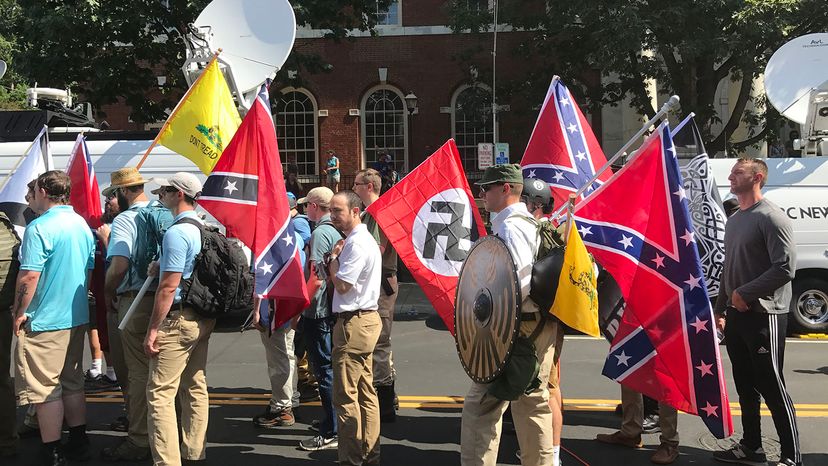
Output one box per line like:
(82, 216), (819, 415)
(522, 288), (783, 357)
(66, 134), (103, 228)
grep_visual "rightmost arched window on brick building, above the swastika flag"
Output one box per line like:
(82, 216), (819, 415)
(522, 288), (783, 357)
(451, 85), (494, 173)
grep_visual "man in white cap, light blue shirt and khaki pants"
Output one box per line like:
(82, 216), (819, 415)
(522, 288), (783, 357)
(144, 172), (216, 464)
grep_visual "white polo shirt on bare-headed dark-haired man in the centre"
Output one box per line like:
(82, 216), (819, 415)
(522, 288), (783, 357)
(332, 224), (382, 313)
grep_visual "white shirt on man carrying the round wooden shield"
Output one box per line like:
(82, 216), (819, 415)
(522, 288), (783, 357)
(492, 202), (540, 312)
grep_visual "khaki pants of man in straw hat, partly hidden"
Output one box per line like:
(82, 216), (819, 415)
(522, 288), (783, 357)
(118, 293), (155, 448)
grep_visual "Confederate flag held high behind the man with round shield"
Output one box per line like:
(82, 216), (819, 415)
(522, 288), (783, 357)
(520, 76), (612, 206)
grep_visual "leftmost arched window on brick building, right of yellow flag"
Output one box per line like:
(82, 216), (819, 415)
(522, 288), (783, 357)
(273, 88), (319, 181)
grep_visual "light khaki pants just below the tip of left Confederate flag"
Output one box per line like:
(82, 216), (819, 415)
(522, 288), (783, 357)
(259, 327), (298, 412)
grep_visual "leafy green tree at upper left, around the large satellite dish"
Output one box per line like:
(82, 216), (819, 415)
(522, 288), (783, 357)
(0, 0), (390, 122)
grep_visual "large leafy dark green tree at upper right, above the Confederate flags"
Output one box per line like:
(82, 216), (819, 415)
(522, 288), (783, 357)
(449, 0), (828, 152)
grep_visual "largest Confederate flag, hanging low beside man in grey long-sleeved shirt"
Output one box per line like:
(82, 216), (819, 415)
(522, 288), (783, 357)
(574, 123), (733, 438)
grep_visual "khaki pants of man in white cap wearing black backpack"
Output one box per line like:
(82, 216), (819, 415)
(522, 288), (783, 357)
(147, 308), (216, 466)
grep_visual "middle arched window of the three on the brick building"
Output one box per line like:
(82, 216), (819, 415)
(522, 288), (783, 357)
(362, 86), (408, 171)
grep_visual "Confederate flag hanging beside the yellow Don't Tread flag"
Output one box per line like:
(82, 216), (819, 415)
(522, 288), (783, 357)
(198, 84), (309, 327)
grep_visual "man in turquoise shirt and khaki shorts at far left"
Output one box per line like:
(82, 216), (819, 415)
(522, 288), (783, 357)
(12, 170), (95, 464)
